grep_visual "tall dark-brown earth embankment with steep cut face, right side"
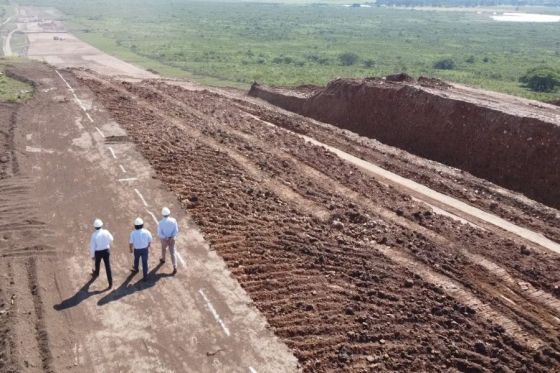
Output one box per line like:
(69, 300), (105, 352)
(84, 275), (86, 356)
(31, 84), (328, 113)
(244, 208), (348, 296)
(249, 78), (560, 208)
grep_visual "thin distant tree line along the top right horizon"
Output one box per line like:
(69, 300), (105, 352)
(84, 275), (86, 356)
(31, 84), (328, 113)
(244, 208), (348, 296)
(375, 0), (560, 7)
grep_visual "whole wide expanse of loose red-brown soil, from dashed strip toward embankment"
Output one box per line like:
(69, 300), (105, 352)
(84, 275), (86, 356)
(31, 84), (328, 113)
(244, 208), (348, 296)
(80, 73), (560, 372)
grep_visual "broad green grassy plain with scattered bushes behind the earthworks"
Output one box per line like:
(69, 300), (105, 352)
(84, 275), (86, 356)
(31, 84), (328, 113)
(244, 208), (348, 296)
(15, 0), (560, 100)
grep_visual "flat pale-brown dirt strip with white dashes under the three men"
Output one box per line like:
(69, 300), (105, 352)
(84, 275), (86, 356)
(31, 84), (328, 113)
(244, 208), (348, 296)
(7, 62), (296, 372)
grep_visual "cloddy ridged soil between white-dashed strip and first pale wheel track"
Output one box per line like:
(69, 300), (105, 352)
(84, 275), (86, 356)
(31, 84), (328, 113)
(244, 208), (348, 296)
(80, 74), (557, 371)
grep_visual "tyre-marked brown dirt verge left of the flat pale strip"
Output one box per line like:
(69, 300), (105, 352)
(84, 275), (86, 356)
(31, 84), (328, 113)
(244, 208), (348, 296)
(0, 91), (56, 372)
